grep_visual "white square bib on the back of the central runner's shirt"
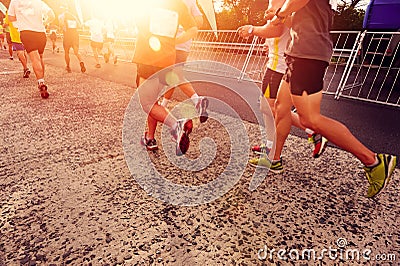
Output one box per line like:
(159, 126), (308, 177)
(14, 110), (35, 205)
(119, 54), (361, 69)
(150, 8), (178, 38)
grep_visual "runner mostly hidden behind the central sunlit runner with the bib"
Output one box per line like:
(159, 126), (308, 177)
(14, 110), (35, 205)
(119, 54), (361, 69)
(161, 0), (208, 123)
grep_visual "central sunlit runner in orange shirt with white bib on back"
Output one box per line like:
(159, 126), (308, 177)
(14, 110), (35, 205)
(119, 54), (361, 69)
(133, 0), (197, 155)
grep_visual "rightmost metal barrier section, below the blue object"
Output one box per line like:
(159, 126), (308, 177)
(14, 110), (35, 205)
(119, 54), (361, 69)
(337, 31), (400, 106)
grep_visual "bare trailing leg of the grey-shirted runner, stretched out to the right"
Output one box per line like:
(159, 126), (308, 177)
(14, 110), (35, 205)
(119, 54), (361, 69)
(292, 92), (376, 165)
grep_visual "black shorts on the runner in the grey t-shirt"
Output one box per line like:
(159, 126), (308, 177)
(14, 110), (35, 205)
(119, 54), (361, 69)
(283, 56), (329, 96)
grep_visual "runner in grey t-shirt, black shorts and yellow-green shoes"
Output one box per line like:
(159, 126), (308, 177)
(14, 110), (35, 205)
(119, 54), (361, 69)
(255, 0), (397, 198)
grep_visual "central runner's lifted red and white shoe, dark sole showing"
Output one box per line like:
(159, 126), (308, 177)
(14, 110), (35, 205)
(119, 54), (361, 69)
(171, 119), (193, 156)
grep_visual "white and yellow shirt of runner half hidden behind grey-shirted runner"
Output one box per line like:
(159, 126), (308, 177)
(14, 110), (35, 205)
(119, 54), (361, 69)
(265, 24), (290, 73)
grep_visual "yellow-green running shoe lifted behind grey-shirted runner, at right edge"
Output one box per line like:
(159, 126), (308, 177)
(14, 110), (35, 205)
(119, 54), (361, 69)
(364, 154), (397, 198)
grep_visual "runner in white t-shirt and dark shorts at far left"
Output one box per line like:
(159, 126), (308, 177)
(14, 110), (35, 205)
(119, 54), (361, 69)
(8, 0), (55, 99)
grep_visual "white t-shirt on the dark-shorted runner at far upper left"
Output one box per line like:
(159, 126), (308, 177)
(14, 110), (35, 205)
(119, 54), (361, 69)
(8, 0), (52, 32)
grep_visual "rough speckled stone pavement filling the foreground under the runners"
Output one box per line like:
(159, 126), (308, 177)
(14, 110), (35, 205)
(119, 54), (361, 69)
(0, 48), (400, 265)
